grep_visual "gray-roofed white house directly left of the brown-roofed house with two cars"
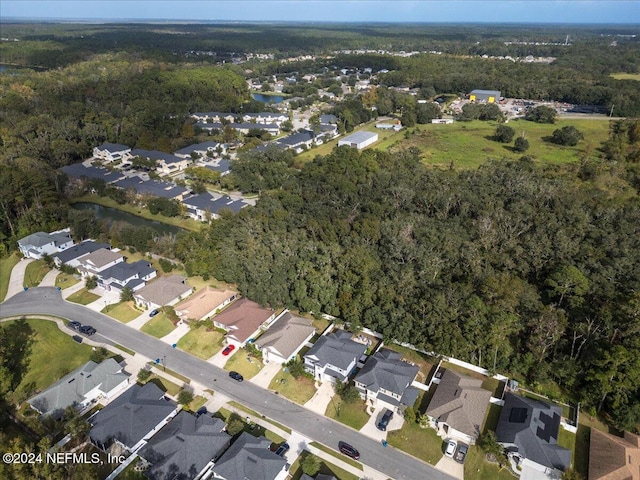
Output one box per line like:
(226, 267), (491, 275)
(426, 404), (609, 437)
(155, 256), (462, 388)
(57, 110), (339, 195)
(353, 348), (420, 413)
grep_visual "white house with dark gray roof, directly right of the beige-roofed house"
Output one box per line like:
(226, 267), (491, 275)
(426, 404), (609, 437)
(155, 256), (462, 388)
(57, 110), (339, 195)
(304, 330), (367, 383)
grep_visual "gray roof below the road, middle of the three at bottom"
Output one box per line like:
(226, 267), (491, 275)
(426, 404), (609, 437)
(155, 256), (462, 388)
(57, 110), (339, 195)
(138, 410), (231, 480)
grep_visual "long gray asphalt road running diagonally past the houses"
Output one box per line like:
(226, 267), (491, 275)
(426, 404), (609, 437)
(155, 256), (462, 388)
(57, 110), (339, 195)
(0, 287), (453, 480)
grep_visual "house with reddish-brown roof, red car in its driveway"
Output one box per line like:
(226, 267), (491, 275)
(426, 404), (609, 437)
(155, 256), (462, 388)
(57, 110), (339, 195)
(213, 297), (275, 347)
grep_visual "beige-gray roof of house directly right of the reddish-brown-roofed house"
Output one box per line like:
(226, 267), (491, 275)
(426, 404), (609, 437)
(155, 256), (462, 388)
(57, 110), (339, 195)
(255, 312), (316, 358)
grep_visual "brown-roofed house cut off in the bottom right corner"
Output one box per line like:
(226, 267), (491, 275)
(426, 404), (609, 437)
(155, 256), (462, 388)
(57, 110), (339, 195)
(588, 428), (640, 480)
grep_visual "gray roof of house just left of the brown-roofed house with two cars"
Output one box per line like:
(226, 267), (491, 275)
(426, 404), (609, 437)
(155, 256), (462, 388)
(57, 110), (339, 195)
(354, 348), (420, 402)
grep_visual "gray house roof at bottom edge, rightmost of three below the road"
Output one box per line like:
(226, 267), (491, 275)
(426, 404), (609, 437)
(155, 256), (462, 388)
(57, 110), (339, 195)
(213, 432), (287, 480)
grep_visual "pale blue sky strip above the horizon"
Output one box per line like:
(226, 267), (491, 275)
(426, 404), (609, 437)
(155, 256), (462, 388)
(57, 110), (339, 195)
(0, 0), (640, 24)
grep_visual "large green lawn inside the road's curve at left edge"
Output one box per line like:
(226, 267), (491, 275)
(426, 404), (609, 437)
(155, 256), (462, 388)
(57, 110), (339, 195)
(2, 319), (92, 401)
